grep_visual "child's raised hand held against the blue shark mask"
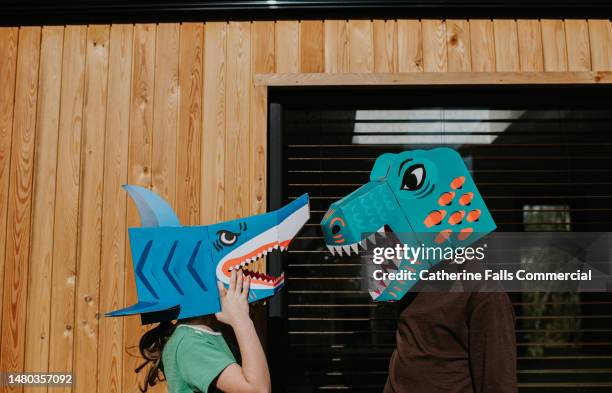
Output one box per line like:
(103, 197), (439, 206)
(215, 270), (251, 327)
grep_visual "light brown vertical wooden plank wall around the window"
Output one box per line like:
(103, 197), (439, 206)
(0, 20), (612, 393)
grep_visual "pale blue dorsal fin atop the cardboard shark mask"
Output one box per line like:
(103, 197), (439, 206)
(123, 184), (181, 227)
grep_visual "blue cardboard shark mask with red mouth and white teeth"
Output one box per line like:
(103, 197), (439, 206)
(106, 185), (310, 323)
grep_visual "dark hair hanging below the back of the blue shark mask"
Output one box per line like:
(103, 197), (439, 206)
(134, 322), (177, 393)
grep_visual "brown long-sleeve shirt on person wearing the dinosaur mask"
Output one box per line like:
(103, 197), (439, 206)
(384, 293), (517, 393)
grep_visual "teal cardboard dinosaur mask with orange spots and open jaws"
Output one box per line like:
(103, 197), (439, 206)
(321, 148), (496, 301)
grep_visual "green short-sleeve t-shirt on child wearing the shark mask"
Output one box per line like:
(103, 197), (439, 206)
(162, 325), (236, 393)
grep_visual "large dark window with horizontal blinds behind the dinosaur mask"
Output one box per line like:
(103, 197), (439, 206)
(269, 86), (612, 393)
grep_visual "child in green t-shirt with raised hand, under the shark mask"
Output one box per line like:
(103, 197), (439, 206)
(136, 270), (271, 393)
